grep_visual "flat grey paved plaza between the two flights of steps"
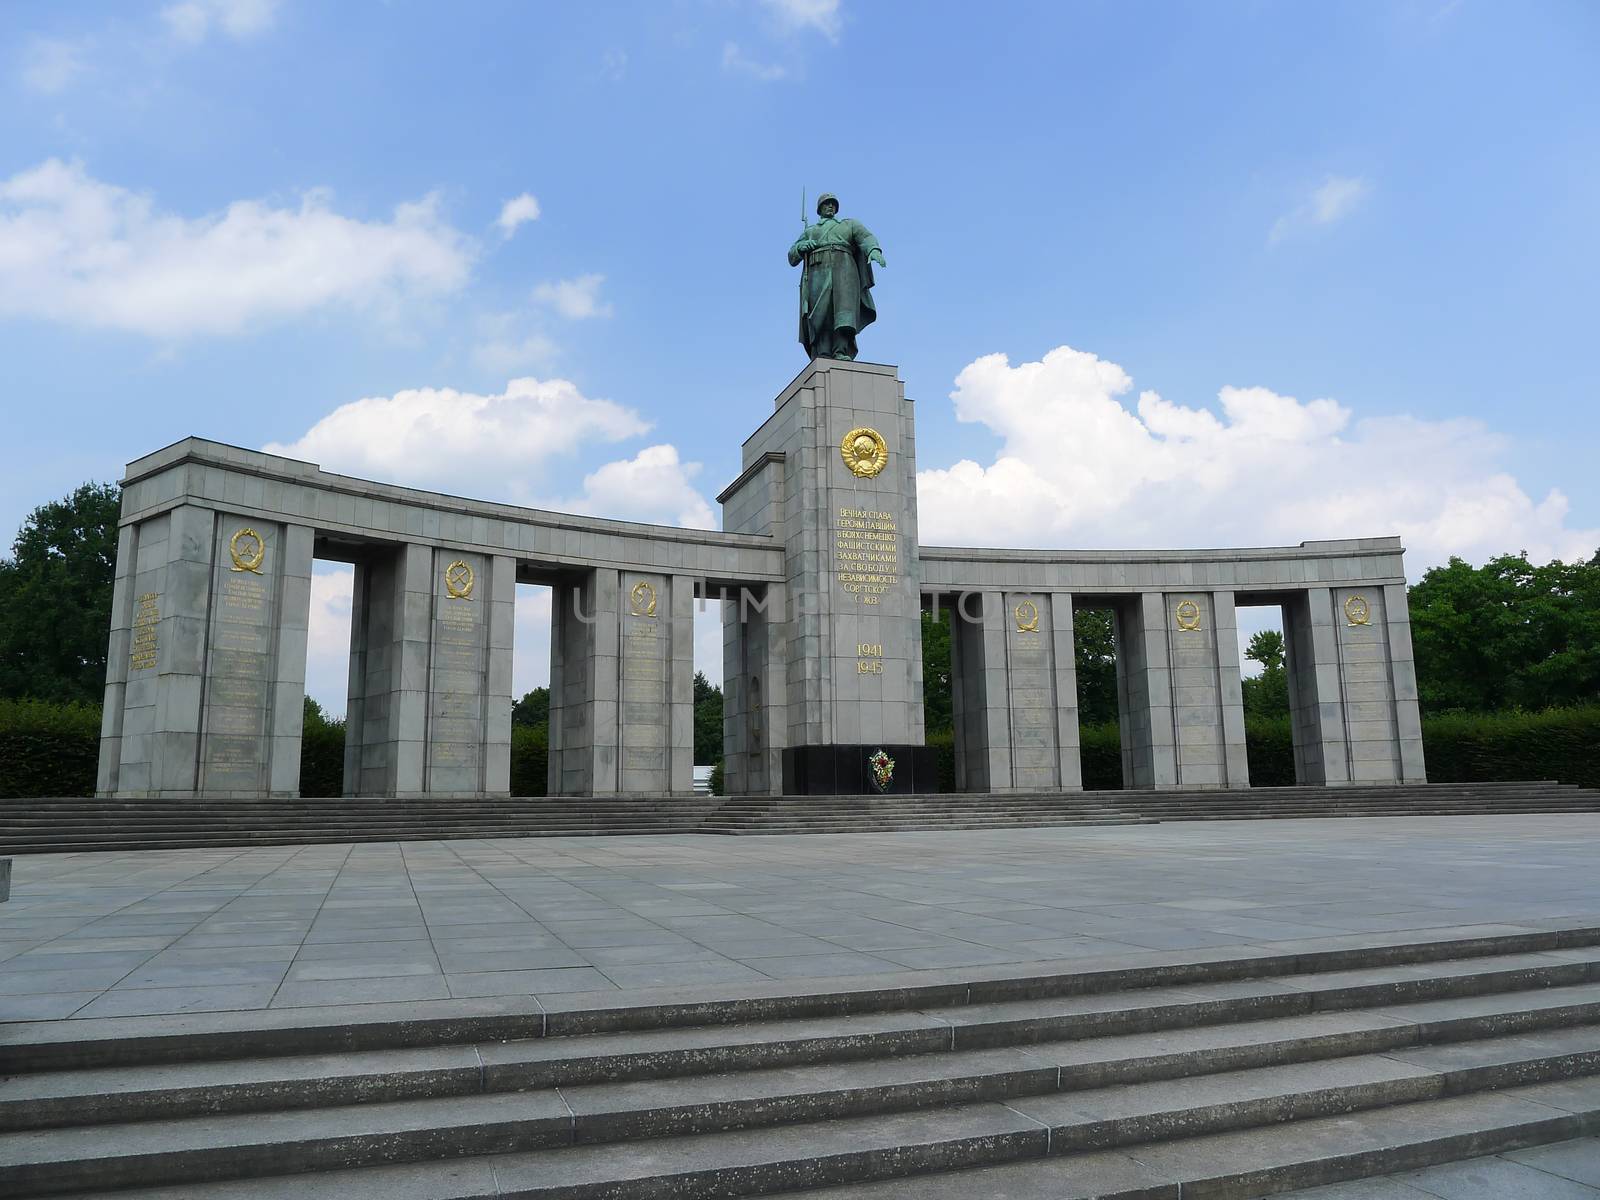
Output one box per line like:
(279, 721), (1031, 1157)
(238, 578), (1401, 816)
(0, 814), (1600, 1021)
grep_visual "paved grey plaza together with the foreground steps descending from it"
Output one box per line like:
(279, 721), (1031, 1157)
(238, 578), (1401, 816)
(0, 811), (1600, 1200)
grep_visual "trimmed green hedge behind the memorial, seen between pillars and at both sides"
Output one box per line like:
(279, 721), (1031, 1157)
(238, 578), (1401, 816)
(0, 699), (1600, 798)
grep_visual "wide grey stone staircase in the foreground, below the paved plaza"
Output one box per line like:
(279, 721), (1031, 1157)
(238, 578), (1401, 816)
(0, 926), (1600, 1200)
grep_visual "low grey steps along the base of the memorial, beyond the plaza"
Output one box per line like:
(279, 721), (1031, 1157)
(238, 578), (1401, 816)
(9, 781), (1600, 854)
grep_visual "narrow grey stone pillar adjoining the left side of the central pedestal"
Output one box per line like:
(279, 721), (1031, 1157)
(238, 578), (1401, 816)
(722, 584), (789, 795)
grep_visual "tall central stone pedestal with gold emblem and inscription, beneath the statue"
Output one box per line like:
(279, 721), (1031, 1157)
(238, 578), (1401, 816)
(718, 358), (936, 794)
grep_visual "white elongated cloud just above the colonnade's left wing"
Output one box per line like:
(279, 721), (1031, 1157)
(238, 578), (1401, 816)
(266, 378), (650, 494)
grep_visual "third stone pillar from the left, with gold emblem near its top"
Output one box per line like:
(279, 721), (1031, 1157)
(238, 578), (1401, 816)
(550, 568), (694, 795)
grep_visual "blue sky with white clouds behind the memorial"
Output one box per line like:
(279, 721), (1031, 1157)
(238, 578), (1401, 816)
(0, 0), (1600, 710)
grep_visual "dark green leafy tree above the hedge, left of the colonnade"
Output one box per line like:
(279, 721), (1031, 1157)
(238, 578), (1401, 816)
(0, 483), (122, 704)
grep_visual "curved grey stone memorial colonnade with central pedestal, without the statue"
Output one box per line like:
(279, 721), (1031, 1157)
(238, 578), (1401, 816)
(98, 358), (1426, 809)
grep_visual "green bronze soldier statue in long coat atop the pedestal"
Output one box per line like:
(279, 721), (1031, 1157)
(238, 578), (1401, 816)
(789, 192), (888, 358)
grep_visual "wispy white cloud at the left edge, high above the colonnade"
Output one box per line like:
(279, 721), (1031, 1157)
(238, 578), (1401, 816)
(0, 158), (475, 338)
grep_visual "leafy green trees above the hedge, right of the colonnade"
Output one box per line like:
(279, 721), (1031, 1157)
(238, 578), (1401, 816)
(1410, 554), (1600, 712)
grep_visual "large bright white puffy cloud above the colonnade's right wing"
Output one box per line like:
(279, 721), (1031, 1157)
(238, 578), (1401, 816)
(917, 346), (1600, 573)
